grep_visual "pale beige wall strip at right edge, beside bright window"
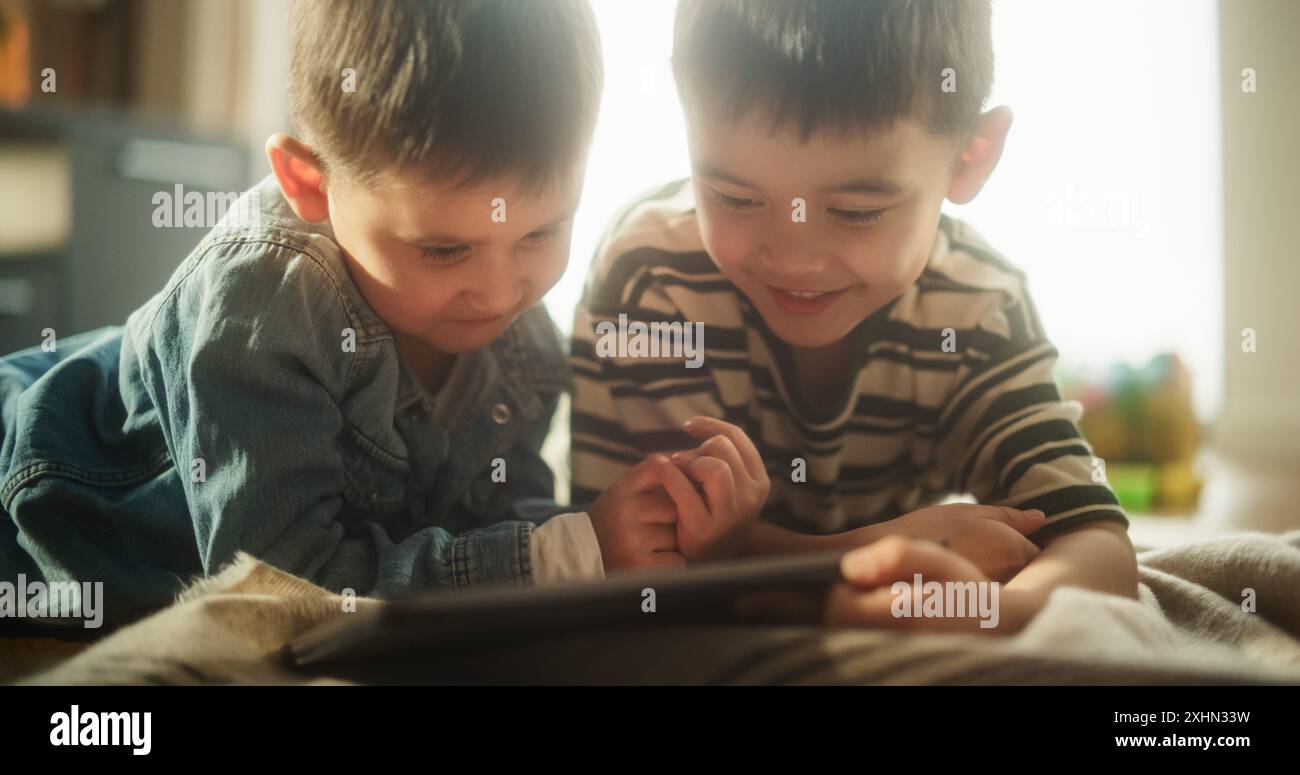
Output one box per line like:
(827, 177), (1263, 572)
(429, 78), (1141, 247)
(1214, 0), (1300, 464)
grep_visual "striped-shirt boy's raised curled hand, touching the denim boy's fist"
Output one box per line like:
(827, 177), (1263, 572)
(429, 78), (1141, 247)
(668, 417), (772, 560)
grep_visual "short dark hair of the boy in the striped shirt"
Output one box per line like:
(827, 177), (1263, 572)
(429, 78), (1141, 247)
(672, 0), (993, 144)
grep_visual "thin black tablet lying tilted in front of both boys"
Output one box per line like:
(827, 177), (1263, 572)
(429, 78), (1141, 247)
(285, 551), (844, 667)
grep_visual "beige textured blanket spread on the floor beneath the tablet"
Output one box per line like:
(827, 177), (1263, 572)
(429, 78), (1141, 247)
(10, 531), (1300, 684)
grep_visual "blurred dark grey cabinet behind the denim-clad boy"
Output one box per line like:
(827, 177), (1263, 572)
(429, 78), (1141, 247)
(0, 109), (250, 354)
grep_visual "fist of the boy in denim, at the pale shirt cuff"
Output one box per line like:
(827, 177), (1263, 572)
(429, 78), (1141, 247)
(588, 455), (702, 572)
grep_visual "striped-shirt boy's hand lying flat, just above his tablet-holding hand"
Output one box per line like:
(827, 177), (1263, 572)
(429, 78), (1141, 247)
(870, 503), (1044, 581)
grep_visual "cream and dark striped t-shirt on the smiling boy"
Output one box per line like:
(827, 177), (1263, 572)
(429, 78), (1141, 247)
(571, 181), (1127, 541)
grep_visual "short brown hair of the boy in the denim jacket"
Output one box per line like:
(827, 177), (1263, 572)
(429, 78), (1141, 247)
(289, 0), (603, 189)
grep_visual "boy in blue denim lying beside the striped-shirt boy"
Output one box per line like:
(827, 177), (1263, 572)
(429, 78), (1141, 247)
(0, 0), (712, 624)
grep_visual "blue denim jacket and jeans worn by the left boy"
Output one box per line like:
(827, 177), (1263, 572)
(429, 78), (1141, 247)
(0, 178), (567, 624)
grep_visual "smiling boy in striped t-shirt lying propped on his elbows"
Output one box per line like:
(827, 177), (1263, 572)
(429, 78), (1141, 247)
(571, 0), (1136, 632)
